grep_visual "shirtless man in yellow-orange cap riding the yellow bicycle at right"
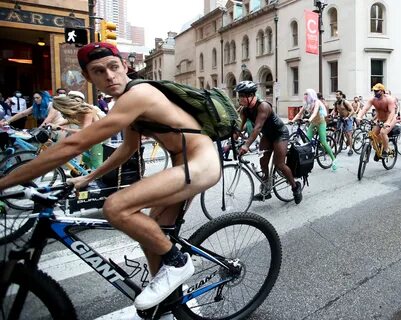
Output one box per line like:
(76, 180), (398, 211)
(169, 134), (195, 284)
(356, 83), (397, 158)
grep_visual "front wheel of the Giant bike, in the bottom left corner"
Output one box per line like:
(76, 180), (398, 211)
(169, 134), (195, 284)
(0, 263), (78, 320)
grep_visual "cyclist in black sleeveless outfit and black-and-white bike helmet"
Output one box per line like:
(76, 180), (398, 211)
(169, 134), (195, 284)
(235, 81), (302, 204)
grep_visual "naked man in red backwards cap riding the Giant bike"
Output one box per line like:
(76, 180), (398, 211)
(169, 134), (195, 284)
(0, 43), (221, 310)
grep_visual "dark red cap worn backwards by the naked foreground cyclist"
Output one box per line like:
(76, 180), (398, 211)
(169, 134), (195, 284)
(77, 42), (121, 70)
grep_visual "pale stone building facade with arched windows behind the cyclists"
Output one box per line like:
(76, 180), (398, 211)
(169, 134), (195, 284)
(174, 0), (401, 115)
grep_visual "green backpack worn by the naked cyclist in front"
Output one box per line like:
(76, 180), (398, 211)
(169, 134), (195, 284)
(125, 80), (241, 141)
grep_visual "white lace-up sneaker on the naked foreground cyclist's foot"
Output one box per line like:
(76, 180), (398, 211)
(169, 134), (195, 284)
(134, 253), (195, 310)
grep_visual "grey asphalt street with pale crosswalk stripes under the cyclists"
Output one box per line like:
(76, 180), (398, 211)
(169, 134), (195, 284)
(21, 152), (401, 320)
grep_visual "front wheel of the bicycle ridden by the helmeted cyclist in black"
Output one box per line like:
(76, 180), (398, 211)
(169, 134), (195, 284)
(200, 163), (255, 220)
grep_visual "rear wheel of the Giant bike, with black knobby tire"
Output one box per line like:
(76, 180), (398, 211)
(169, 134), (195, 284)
(174, 213), (282, 320)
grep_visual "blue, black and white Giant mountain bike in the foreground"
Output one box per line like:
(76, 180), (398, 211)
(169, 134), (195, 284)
(0, 185), (282, 320)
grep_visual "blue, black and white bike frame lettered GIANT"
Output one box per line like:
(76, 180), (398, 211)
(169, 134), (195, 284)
(0, 202), (235, 313)
